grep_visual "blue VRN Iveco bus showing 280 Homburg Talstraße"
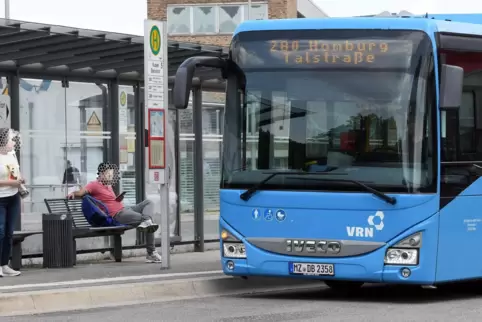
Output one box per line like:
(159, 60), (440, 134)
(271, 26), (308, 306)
(173, 17), (482, 290)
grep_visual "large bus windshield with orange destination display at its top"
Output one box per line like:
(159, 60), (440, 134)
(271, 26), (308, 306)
(221, 30), (437, 193)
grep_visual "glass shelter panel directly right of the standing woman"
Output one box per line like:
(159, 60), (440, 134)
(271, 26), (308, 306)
(19, 79), (67, 253)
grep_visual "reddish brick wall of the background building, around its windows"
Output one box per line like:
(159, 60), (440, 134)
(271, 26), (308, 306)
(147, 0), (297, 46)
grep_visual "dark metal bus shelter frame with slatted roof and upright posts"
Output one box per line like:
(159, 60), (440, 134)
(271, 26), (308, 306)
(0, 19), (228, 260)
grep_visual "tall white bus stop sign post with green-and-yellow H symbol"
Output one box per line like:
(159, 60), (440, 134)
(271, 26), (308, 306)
(144, 20), (171, 269)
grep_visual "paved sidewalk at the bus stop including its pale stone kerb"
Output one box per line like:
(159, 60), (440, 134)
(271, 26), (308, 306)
(0, 250), (320, 320)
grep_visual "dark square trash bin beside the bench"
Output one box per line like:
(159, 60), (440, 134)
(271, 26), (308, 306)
(42, 214), (75, 268)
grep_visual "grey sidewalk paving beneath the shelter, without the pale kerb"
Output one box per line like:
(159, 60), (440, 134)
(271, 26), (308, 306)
(0, 250), (221, 292)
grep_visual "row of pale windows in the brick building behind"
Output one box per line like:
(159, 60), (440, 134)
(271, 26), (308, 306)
(167, 2), (268, 35)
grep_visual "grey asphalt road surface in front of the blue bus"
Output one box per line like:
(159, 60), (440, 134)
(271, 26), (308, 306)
(8, 283), (482, 322)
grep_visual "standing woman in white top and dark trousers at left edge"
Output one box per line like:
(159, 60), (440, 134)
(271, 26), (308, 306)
(0, 128), (24, 277)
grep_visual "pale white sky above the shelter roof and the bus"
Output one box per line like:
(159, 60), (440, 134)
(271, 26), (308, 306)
(0, 0), (482, 35)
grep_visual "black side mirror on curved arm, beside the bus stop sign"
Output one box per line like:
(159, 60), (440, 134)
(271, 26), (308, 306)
(172, 57), (226, 109)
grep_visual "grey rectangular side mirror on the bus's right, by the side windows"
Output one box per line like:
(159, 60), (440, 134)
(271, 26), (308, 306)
(440, 64), (464, 110)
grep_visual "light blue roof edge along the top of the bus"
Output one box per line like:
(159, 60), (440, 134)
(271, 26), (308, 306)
(234, 15), (482, 36)
